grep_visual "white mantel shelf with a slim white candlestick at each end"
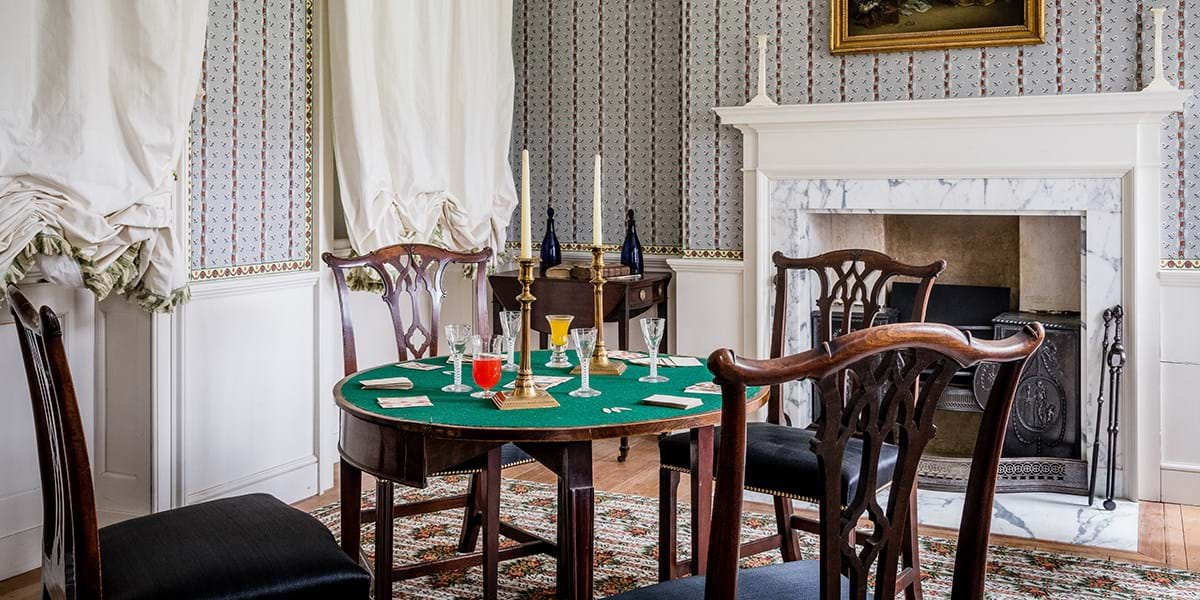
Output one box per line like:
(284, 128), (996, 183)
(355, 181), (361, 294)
(713, 90), (1192, 131)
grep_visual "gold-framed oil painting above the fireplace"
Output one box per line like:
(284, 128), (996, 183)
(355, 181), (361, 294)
(829, 0), (1045, 54)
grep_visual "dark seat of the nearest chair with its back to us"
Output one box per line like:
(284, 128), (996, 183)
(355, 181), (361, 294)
(610, 560), (854, 600)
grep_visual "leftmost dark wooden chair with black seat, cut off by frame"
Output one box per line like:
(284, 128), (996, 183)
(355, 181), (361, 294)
(5, 287), (371, 600)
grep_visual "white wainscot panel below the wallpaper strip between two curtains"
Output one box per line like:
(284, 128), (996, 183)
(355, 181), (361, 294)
(176, 272), (328, 504)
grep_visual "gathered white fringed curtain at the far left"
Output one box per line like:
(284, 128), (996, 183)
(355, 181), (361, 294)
(0, 0), (208, 310)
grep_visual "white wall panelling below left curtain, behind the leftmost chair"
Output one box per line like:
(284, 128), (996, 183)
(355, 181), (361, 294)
(0, 284), (96, 580)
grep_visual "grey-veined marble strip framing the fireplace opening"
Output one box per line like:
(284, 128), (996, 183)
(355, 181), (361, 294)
(768, 178), (1122, 477)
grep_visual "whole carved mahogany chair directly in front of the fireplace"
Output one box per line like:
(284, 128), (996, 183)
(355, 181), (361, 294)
(659, 250), (946, 599)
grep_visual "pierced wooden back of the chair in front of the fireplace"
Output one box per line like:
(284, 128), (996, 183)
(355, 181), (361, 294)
(767, 248), (946, 424)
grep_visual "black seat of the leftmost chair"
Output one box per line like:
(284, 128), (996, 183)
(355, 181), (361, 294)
(100, 493), (371, 600)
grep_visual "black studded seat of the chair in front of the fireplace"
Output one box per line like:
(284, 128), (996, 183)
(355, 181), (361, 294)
(659, 422), (898, 505)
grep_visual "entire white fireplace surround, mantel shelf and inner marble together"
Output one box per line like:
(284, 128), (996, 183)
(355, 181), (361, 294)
(715, 90), (1190, 500)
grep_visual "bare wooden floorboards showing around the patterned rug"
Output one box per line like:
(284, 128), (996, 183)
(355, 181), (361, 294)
(0, 437), (1200, 600)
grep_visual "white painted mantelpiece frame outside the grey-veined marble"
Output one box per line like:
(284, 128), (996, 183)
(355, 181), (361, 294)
(714, 90), (1192, 499)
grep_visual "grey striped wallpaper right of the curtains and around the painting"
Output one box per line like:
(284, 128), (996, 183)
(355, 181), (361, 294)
(514, 0), (1200, 268)
